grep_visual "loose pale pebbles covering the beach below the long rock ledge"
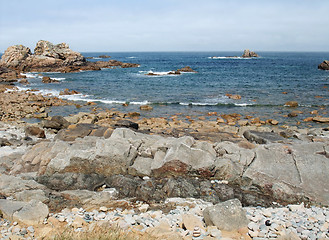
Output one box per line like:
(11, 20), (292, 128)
(0, 199), (329, 239)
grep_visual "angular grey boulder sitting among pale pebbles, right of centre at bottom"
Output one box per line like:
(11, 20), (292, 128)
(203, 199), (249, 231)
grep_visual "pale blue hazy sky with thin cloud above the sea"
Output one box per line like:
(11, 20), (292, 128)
(0, 0), (329, 52)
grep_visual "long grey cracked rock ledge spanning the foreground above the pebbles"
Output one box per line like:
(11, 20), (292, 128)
(4, 128), (329, 205)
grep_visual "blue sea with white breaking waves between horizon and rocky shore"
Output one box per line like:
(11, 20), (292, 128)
(9, 52), (329, 124)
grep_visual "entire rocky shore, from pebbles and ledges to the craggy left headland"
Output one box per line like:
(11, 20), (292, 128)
(0, 41), (329, 239)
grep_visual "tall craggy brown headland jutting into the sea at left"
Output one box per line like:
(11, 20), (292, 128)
(0, 40), (139, 77)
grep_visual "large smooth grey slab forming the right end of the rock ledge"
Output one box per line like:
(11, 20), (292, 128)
(242, 142), (329, 205)
